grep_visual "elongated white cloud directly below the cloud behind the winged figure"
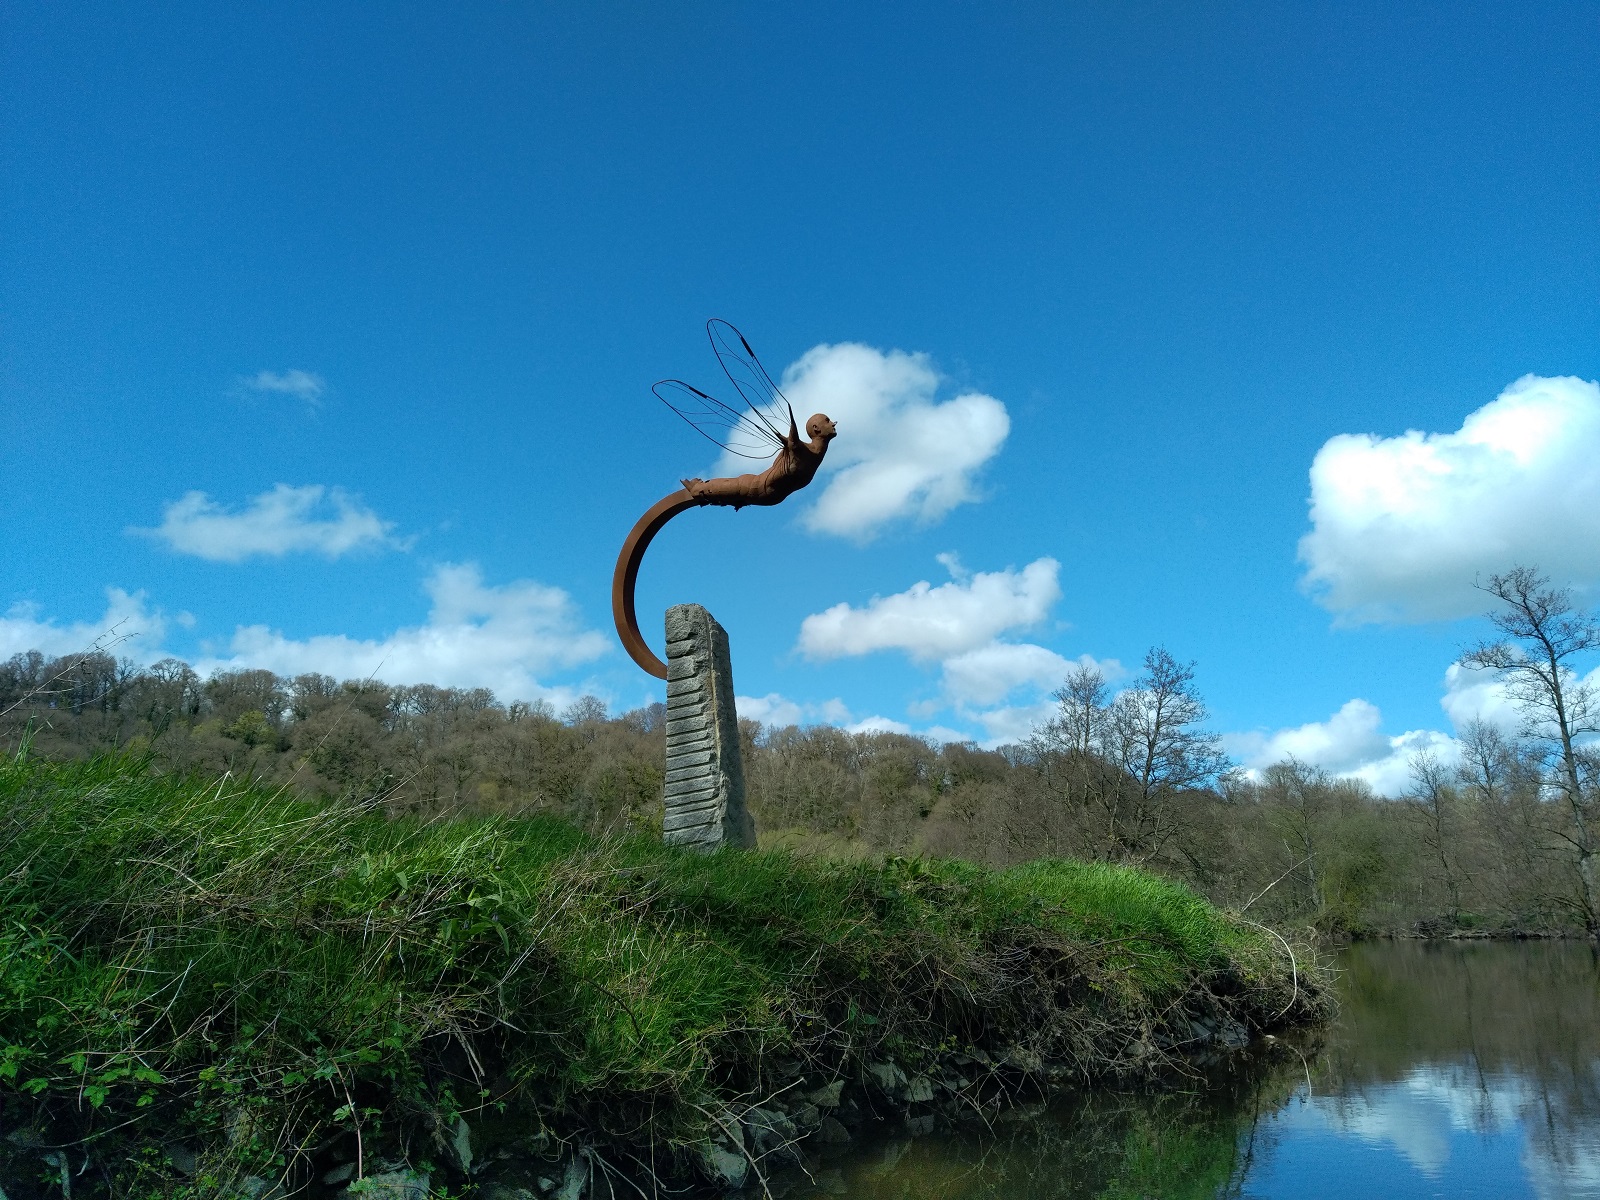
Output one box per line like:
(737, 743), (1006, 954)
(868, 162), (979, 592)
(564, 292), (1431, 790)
(798, 558), (1061, 662)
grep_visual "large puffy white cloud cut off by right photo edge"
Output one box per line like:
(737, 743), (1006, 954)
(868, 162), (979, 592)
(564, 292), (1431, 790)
(1299, 374), (1600, 622)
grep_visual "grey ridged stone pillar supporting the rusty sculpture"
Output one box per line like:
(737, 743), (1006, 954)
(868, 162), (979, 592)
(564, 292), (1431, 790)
(662, 605), (755, 850)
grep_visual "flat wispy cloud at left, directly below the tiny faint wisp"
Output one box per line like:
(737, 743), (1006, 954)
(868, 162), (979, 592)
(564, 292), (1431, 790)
(139, 483), (405, 563)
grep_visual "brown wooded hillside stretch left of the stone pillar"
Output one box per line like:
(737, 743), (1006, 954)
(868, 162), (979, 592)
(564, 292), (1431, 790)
(0, 653), (664, 830)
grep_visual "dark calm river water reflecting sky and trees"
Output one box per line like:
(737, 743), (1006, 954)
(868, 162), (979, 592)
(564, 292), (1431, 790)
(768, 942), (1600, 1200)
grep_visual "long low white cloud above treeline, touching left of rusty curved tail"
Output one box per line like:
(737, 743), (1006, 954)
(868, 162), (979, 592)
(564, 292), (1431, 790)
(195, 563), (610, 707)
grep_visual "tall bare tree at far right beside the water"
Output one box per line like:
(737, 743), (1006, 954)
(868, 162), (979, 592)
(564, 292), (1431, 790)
(1461, 566), (1600, 933)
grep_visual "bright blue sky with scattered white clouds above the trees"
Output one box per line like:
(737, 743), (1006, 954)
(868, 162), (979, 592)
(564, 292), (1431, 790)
(0, 3), (1600, 793)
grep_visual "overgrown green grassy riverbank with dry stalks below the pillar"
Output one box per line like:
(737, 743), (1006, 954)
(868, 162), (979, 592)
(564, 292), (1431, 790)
(0, 758), (1322, 1200)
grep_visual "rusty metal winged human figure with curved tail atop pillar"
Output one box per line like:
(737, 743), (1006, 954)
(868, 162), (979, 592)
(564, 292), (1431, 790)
(611, 320), (838, 678)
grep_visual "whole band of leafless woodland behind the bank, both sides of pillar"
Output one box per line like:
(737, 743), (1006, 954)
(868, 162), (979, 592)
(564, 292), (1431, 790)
(0, 568), (1600, 934)
